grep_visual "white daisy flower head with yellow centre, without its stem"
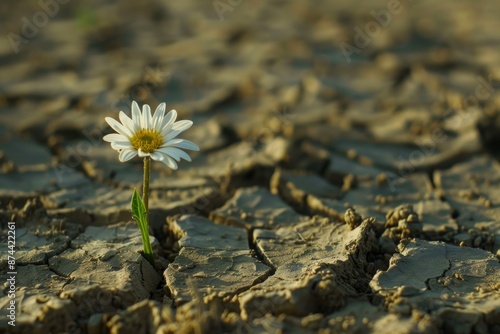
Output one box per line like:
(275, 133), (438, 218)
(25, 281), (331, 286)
(103, 101), (200, 169)
